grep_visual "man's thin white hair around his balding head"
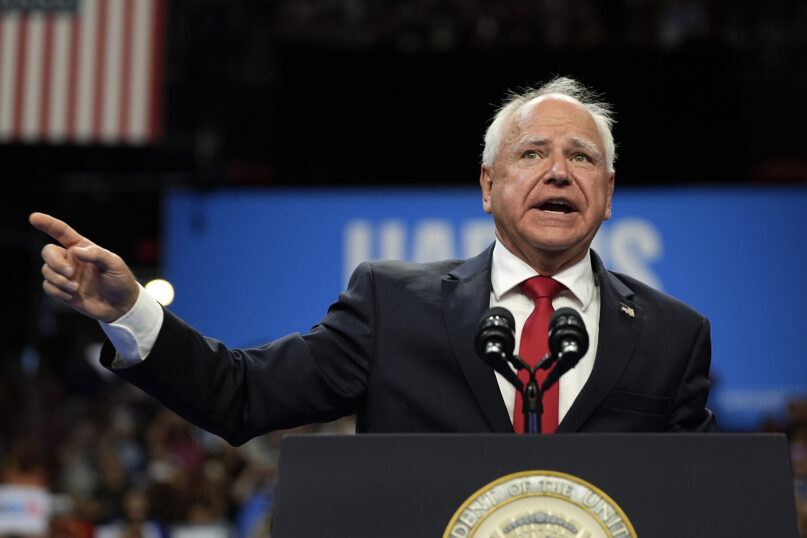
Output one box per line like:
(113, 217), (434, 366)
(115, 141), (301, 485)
(482, 77), (616, 172)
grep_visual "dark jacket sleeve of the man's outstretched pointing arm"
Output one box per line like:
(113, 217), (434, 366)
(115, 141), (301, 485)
(101, 264), (376, 445)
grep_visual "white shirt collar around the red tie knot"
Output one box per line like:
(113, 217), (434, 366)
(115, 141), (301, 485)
(490, 239), (594, 312)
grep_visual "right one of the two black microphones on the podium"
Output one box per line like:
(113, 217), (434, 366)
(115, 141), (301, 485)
(541, 307), (588, 391)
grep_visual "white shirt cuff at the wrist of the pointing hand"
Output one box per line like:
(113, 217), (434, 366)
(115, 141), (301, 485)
(98, 284), (164, 368)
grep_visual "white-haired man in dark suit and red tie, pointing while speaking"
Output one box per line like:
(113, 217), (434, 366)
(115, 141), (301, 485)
(30, 78), (717, 445)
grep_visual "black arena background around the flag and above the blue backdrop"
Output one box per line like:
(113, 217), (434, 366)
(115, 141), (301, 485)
(0, 0), (807, 420)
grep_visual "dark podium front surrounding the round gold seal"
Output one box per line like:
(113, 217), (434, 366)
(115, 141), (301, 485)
(271, 433), (798, 538)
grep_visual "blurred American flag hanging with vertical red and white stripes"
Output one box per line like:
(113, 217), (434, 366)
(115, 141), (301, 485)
(0, 0), (167, 144)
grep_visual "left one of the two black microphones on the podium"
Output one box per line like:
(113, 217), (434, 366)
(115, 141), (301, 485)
(476, 306), (524, 390)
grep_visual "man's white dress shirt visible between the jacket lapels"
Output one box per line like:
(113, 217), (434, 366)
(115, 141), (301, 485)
(490, 239), (600, 422)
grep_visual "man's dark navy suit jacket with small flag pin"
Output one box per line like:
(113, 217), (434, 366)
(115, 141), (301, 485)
(102, 247), (716, 444)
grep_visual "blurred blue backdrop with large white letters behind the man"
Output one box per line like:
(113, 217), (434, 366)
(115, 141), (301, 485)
(163, 188), (807, 429)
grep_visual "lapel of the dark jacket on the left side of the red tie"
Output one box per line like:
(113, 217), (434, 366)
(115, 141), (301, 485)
(442, 245), (513, 432)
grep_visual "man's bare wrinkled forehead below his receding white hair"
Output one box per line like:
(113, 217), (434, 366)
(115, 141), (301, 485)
(508, 94), (602, 147)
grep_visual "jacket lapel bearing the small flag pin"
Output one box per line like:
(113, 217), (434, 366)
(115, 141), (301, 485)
(558, 251), (642, 432)
